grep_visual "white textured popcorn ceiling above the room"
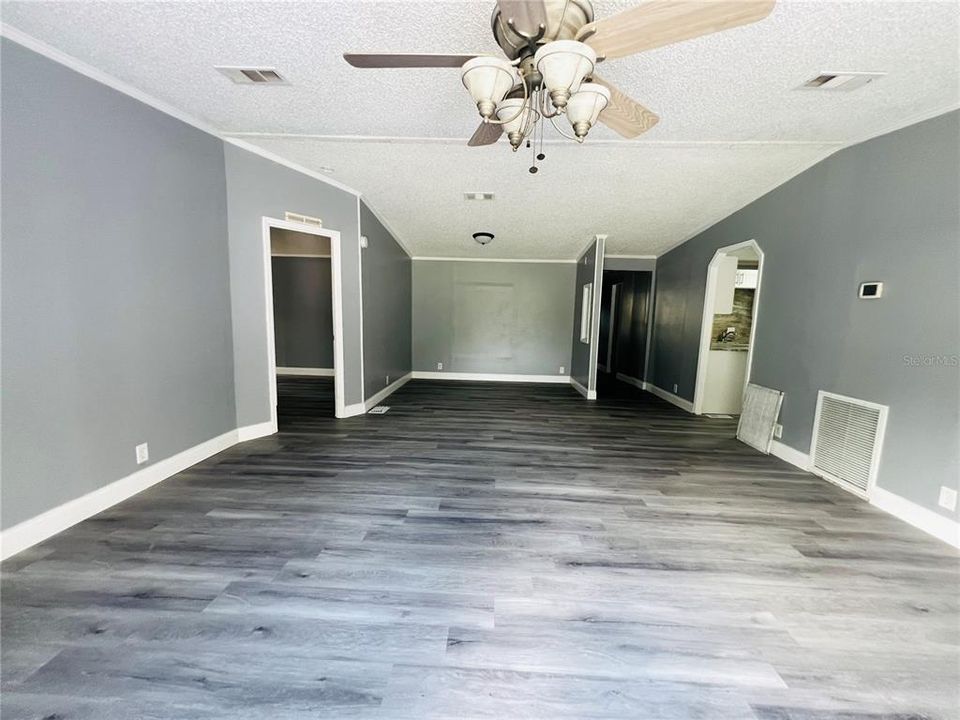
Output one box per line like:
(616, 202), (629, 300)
(2, 0), (960, 258)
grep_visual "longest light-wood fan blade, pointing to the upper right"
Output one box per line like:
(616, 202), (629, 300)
(577, 0), (775, 60)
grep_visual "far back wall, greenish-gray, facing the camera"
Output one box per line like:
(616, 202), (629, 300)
(413, 260), (576, 375)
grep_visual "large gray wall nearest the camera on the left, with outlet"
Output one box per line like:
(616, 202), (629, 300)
(0, 39), (236, 529)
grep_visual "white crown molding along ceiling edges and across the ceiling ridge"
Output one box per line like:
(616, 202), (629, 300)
(0, 23), (960, 262)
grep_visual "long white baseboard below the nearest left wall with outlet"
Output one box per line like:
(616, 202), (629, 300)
(0, 430), (238, 560)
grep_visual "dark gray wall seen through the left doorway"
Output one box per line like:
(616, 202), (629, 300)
(272, 256), (333, 368)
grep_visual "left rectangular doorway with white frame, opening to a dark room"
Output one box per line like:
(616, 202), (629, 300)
(263, 217), (344, 431)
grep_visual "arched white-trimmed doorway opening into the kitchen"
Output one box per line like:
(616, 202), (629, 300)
(693, 240), (763, 415)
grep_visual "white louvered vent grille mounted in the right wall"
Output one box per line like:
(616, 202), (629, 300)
(810, 390), (887, 495)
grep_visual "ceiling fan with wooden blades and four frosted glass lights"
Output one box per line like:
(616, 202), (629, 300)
(343, 0), (775, 172)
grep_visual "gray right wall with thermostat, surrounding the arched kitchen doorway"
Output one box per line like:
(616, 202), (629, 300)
(651, 112), (960, 517)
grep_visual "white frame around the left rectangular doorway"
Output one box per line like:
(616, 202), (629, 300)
(262, 216), (345, 424)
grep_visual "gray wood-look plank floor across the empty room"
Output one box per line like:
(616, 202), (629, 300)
(2, 379), (960, 720)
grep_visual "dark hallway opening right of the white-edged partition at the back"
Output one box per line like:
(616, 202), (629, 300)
(597, 270), (653, 397)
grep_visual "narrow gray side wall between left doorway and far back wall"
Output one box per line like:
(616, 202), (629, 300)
(360, 200), (413, 398)
